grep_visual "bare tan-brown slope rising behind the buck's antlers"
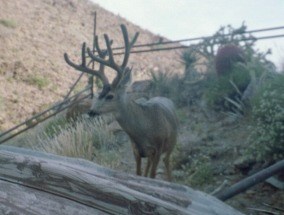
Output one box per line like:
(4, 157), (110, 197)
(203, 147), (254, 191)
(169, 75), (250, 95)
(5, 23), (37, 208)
(0, 0), (183, 131)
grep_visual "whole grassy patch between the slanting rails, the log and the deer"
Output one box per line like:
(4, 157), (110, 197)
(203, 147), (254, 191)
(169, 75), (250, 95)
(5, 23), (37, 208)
(10, 115), (115, 162)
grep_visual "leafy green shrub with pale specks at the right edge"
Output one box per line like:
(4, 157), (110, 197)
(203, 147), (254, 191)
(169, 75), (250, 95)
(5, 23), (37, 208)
(248, 74), (284, 161)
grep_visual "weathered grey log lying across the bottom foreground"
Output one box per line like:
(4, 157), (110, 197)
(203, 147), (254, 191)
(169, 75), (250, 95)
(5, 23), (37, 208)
(0, 146), (244, 215)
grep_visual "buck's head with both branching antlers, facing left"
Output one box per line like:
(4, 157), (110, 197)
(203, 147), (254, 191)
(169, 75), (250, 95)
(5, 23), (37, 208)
(64, 25), (139, 116)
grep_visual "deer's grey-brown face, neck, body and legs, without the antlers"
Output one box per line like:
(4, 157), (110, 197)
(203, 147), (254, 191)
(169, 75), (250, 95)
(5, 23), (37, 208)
(90, 86), (178, 180)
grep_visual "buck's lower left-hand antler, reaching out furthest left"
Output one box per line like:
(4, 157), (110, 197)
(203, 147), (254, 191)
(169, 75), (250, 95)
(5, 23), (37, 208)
(64, 43), (109, 85)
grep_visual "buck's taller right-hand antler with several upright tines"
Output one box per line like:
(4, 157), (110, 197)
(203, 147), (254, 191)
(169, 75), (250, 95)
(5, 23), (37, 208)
(87, 25), (139, 87)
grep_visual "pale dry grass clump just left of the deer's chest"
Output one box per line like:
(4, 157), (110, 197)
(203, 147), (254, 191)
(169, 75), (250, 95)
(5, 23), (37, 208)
(33, 118), (115, 160)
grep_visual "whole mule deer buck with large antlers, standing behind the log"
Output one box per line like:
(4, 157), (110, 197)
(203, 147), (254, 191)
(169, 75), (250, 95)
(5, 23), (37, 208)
(64, 25), (178, 180)
